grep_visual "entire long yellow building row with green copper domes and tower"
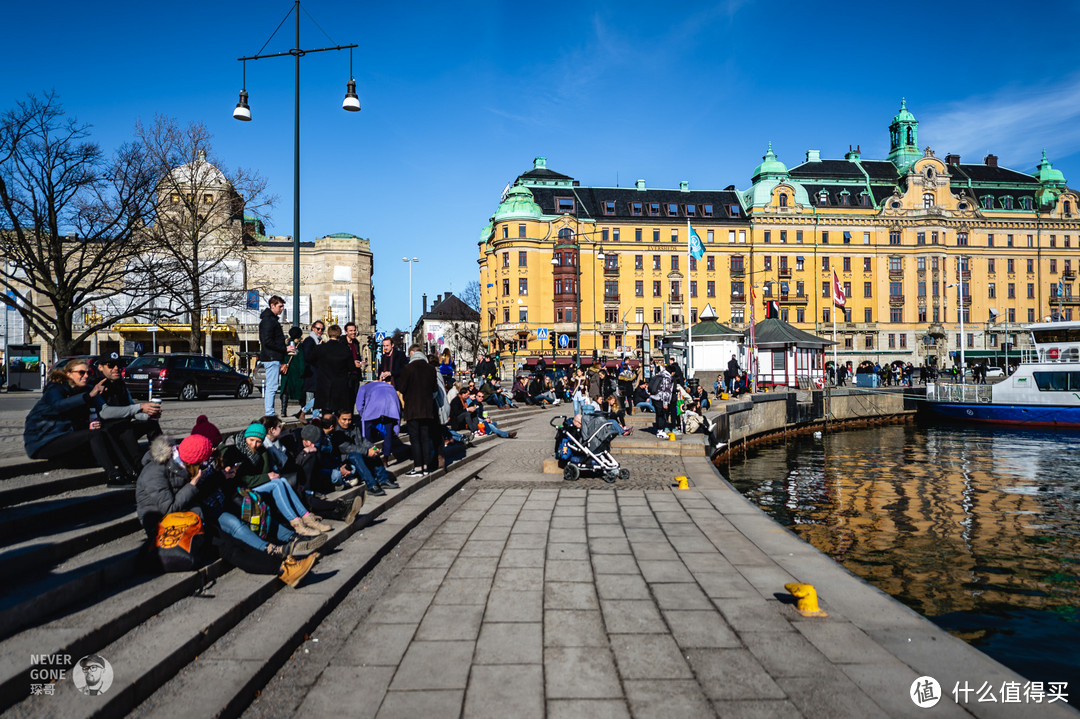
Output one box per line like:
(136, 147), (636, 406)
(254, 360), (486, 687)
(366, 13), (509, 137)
(480, 104), (1080, 369)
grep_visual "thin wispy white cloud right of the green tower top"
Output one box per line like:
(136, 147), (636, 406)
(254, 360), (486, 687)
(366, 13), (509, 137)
(919, 74), (1080, 172)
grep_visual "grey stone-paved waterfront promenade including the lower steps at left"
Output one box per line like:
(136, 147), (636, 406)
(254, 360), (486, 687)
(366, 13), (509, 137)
(0, 399), (1077, 718)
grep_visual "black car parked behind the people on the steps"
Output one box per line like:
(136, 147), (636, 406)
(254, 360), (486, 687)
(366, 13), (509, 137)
(124, 352), (252, 401)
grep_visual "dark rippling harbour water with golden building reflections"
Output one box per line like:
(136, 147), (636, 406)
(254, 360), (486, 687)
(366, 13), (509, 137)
(719, 425), (1080, 689)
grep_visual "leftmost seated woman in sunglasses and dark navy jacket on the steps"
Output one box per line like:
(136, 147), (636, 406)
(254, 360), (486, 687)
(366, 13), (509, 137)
(23, 360), (136, 485)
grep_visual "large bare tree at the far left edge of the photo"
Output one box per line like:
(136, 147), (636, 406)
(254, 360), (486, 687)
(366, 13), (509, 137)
(0, 93), (156, 356)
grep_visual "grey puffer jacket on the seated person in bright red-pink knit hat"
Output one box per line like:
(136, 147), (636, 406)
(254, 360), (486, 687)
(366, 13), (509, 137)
(135, 435), (199, 539)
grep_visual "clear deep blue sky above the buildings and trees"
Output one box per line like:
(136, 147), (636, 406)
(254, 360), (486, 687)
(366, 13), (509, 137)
(0, 0), (1080, 328)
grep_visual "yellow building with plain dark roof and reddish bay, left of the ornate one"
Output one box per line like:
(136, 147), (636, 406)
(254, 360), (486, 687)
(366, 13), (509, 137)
(480, 158), (750, 363)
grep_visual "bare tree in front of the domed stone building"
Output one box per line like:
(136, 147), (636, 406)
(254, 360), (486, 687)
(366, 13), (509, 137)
(135, 117), (273, 352)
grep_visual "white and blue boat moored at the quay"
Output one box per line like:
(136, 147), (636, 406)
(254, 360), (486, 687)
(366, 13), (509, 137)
(923, 322), (1080, 429)
